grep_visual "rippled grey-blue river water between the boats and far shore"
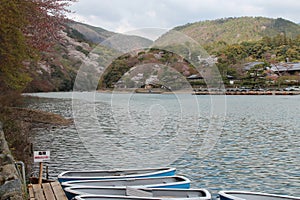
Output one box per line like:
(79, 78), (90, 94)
(28, 93), (300, 196)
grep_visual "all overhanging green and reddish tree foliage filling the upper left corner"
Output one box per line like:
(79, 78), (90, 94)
(0, 0), (73, 95)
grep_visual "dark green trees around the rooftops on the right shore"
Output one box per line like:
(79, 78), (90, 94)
(216, 34), (300, 85)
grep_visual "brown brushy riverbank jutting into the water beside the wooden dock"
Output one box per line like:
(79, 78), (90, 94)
(2, 103), (72, 188)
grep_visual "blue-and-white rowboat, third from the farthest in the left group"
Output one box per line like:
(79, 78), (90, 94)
(65, 186), (211, 200)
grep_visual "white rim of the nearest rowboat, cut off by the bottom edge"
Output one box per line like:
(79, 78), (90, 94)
(74, 195), (161, 200)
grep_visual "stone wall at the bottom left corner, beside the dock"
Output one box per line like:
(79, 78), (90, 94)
(0, 122), (23, 200)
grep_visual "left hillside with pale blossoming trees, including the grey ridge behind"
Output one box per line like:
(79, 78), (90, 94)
(25, 21), (152, 92)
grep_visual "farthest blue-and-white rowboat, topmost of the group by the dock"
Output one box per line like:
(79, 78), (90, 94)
(58, 167), (176, 182)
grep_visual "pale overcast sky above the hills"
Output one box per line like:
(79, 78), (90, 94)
(69, 0), (300, 33)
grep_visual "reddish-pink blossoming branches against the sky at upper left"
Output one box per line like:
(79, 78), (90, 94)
(23, 0), (74, 51)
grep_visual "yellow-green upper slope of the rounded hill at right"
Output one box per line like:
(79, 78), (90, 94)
(174, 17), (300, 45)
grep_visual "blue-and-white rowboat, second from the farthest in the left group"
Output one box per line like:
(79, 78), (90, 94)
(61, 176), (190, 189)
